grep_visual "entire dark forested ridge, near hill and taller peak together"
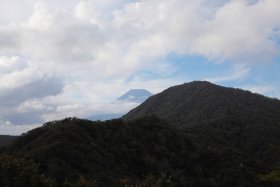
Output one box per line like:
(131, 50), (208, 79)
(0, 81), (280, 187)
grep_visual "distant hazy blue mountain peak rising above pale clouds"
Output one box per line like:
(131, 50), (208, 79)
(117, 89), (153, 103)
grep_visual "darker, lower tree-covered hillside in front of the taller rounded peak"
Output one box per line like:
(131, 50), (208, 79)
(2, 117), (277, 187)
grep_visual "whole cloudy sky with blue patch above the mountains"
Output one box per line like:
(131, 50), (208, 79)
(0, 0), (280, 135)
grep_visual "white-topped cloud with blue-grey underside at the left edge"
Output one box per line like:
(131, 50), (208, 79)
(0, 57), (63, 106)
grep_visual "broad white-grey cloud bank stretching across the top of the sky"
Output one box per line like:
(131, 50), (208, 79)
(0, 0), (280, 80)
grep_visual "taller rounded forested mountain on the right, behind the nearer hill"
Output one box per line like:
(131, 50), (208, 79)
(123, 81), (280, 186)
